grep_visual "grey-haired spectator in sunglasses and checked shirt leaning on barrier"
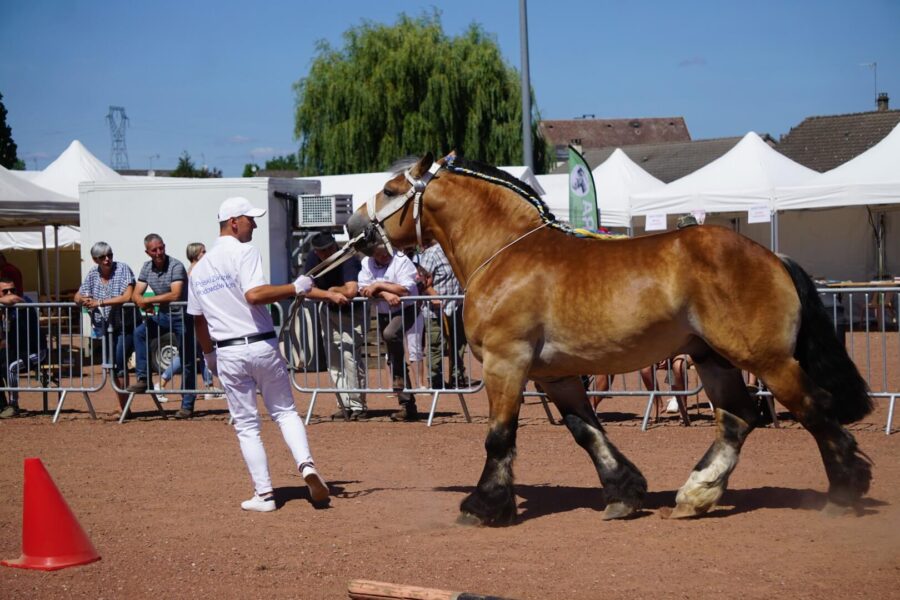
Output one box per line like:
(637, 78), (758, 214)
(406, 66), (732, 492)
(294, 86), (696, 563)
(75, 242), (135, 410)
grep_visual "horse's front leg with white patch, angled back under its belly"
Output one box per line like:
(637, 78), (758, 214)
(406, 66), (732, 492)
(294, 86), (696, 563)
(540, 377), (647, 520)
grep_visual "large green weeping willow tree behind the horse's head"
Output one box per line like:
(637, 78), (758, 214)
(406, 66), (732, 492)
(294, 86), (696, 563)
(294, 11), (548, 175)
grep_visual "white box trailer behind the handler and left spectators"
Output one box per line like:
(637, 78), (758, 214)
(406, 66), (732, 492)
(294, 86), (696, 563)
(78, 177), (320, 284)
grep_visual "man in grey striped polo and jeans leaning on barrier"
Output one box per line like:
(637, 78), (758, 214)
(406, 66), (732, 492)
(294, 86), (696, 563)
(126, 233), (196, 419)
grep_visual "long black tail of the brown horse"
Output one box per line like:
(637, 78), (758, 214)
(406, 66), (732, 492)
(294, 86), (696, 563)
(780, 256), (872, 424)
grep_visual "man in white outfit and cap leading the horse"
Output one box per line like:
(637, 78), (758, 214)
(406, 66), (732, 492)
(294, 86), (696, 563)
(187, 197), (329, 512)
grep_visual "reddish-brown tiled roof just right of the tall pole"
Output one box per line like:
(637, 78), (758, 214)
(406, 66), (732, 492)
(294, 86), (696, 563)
(540, 117), (691, 150)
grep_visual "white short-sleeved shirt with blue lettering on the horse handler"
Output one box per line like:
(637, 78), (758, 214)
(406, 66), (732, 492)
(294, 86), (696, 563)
(187, 236), (274, 341)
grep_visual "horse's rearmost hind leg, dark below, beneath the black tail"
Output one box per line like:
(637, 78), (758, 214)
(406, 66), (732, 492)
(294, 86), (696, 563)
(760, 360), (872, 514)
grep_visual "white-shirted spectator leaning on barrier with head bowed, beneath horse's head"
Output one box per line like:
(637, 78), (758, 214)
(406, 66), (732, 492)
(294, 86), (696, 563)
(359, 246), (419, 421)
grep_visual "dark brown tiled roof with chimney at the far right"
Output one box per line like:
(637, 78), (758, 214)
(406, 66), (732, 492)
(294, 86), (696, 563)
(775, 110), (900, 172)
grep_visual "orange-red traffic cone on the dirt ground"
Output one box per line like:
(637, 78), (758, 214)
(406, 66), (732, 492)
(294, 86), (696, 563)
(0, 458), (100, 571)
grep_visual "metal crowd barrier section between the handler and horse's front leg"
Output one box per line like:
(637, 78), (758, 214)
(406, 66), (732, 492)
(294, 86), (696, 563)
(282, 295), (483, 426)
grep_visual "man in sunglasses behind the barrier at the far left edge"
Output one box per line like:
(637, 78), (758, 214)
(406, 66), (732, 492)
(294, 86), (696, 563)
(0, 277), (47, 419)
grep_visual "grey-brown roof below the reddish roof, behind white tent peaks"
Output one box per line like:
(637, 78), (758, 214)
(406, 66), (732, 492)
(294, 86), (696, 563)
(553, 136), (740, 183)
